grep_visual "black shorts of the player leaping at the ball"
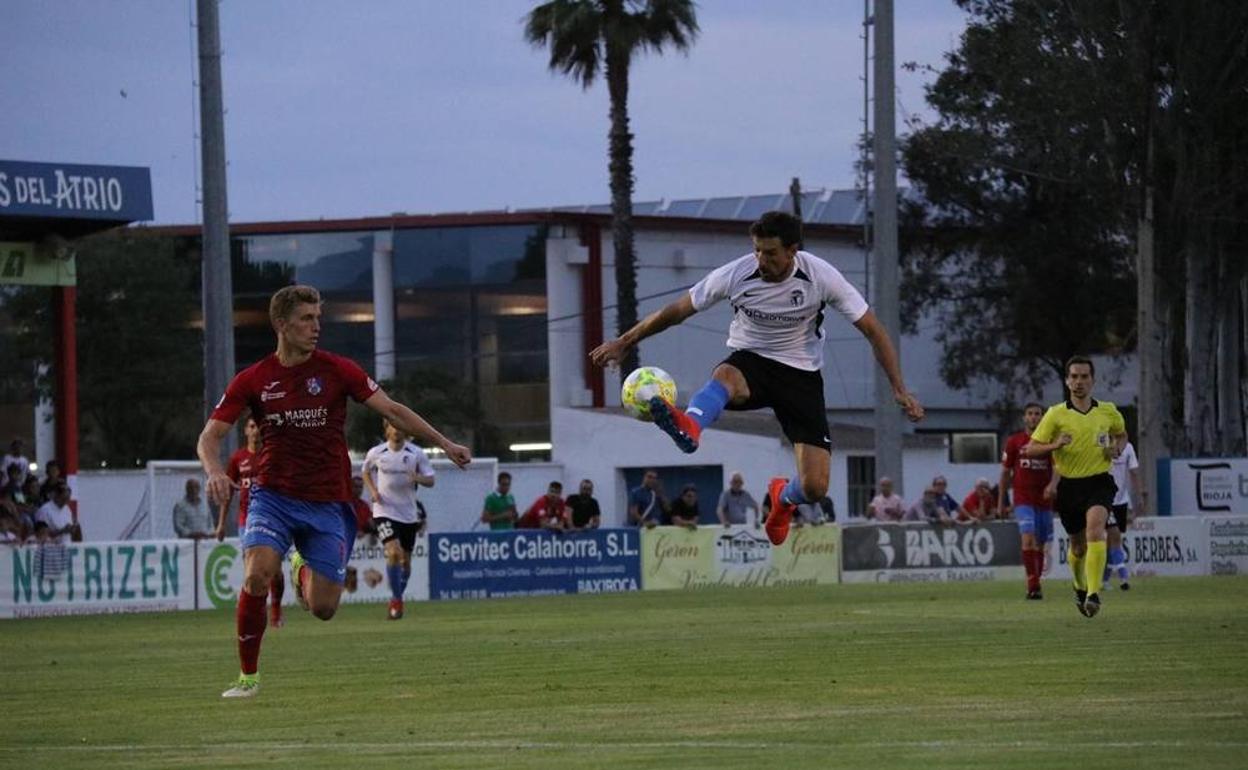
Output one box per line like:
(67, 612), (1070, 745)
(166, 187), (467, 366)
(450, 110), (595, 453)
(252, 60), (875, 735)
(724, 351), (832, 452)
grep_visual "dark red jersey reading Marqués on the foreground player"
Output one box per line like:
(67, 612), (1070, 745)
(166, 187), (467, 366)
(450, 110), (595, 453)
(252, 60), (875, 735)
(212, 351), (377, 502)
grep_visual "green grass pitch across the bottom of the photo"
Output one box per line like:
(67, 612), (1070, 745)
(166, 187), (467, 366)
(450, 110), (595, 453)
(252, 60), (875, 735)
(0, 578), (1248, 770)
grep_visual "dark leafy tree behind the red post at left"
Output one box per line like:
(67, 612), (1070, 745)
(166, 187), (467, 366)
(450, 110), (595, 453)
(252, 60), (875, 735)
(7, 230), (203, 468)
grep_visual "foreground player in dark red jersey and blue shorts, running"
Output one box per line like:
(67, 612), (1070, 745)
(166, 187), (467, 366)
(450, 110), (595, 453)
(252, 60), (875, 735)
(197, 286), (472, 698)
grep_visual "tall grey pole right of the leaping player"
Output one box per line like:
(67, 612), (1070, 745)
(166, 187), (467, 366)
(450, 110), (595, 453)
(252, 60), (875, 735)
(871, 0), (905, 495)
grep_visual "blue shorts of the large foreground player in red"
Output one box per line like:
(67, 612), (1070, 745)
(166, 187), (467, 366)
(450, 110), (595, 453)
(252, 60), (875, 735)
(242, 484), (356, 585)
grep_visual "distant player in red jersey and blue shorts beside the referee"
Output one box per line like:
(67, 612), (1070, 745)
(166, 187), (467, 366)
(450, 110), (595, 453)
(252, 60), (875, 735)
(997, 403), (1053, 599)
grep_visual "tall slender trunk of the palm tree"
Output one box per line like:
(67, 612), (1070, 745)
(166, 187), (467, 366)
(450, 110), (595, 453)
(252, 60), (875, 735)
(607, 45), (639, 373)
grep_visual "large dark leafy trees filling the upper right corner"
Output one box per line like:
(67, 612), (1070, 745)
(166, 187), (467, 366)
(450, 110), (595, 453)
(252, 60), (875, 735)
(904, 0), (1248, 454)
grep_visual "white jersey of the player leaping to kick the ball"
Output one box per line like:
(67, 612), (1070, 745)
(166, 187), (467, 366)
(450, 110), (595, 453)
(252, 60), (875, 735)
(689, 251), (867, 372)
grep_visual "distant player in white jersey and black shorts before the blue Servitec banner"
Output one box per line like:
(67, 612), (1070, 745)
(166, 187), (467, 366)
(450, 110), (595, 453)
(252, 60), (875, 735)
(363, 421), (434, 620)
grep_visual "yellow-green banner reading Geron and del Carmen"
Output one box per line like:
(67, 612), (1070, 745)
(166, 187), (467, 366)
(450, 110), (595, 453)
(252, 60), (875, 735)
(641, 527), (840, 590)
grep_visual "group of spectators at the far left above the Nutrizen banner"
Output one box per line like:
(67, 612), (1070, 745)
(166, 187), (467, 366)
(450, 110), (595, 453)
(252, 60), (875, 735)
(0, 438), (82, 545)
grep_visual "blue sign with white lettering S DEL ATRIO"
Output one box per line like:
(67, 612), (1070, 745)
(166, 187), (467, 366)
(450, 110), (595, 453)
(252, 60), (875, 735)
(0, 160), (152, 222)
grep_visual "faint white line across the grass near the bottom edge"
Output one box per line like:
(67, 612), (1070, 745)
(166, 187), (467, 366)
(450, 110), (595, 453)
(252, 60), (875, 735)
(0, 740), (1248, 754)
